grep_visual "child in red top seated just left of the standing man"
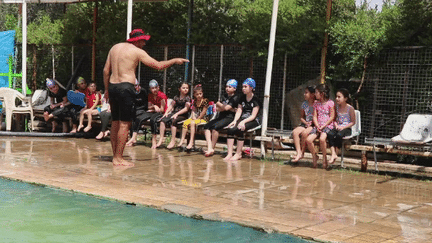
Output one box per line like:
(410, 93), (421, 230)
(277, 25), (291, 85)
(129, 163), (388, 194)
(78, 83), (101, 132)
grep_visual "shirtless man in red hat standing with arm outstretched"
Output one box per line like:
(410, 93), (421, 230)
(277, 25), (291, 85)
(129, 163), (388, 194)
(103, 29), (189, 166)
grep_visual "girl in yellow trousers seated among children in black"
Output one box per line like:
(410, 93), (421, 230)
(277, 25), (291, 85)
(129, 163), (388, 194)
(177, 84), (209, 151)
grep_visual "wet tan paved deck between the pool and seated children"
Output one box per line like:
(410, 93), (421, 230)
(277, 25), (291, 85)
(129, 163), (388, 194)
(0, 137), (432, 243)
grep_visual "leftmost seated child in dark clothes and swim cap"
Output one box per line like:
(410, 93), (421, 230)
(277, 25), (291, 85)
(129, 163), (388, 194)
(43, 78), (70, 132)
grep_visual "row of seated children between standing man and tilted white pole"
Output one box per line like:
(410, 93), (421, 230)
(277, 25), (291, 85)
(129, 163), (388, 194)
(123, 78), (262, 160)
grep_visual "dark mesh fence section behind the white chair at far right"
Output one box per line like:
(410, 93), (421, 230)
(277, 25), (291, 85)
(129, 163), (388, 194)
(360, 47), (432, 138)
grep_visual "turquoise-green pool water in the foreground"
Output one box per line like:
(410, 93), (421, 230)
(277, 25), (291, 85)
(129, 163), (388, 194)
(0, 178), (309, 243)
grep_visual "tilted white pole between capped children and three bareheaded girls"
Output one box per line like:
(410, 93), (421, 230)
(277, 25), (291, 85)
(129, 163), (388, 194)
(261, 0), (279, 157)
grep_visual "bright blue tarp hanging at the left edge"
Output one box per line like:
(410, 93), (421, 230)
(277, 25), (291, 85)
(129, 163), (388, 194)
(0, 30), (15, 87)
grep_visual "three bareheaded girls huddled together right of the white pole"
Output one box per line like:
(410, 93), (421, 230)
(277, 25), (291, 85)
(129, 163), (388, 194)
(293, 84), (356, 168)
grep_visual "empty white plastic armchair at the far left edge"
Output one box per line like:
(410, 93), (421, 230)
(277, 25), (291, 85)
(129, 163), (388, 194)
(0, 88), (34, 131)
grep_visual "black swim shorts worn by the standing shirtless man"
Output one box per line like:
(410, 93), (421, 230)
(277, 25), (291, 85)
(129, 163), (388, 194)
(108, 82), (136, 121)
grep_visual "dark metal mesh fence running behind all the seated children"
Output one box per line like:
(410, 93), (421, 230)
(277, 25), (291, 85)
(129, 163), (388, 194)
(17, 45), (432, 143)
